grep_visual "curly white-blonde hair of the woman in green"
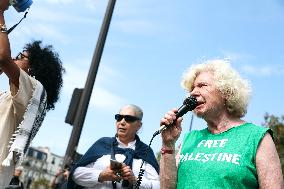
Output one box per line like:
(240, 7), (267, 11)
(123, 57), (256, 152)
(181, 59), (251, 118)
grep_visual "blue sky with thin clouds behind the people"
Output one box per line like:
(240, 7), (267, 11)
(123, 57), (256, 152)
(0, 0), (284, 155)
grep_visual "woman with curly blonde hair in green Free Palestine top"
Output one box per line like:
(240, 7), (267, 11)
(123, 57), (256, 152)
(160, 59), (284, 189)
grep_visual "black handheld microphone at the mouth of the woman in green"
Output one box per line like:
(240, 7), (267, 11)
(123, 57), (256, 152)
(154, 96), (197, 136)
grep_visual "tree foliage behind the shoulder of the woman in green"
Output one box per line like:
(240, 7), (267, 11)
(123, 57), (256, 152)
(263, 113), (284, 175)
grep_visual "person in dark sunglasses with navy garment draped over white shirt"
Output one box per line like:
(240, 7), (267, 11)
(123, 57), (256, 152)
(68, 104), (160, 189)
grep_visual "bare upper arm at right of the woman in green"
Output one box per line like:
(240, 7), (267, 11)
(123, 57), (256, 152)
(256, 133), (284, 189)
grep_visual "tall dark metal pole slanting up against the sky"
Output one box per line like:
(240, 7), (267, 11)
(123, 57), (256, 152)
(63, 0), (116, 166)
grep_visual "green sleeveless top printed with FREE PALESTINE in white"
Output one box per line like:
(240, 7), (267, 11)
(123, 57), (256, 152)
(177, 123), (272, 189)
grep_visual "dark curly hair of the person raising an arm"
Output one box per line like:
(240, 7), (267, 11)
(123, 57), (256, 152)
(24, 41), (65, 111)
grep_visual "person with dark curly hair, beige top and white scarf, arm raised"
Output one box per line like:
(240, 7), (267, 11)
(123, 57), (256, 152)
(0, 0), (64, 188)
